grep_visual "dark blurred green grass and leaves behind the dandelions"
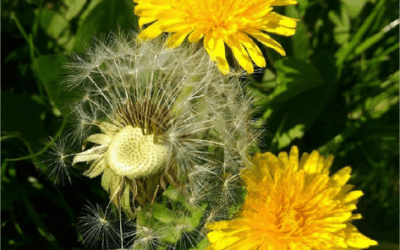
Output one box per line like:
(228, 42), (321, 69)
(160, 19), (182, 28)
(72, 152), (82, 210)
(1, 0), (399, 250)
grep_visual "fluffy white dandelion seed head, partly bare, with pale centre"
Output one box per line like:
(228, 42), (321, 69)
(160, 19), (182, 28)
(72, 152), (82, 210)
(60, 33), (256, 249)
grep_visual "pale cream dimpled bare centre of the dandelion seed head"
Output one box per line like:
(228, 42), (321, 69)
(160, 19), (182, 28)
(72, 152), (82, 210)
(106, 125), (168, 178)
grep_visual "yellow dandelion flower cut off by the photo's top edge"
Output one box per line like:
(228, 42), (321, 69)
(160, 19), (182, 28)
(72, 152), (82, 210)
(133, 0), (297, 74)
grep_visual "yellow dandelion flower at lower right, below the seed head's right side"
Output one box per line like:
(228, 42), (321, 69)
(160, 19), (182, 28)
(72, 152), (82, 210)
(207, 147), (378, 250)
